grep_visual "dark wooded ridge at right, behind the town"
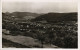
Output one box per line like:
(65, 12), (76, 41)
(34, 12), (78, 22)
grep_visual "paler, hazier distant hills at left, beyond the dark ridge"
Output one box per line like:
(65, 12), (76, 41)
(2, 12), (41, 20)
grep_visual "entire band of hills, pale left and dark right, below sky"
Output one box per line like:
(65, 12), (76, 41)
(2, 12), (78, 22)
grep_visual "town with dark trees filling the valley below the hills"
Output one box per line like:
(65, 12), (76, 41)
(2, 12), (78, 48)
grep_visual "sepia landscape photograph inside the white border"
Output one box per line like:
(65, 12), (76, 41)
(2, 0), (78, 49)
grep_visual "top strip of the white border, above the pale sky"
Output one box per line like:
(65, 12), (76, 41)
(2, 0), (77, 2)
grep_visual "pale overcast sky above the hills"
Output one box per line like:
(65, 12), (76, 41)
(2, 0), (78, 13)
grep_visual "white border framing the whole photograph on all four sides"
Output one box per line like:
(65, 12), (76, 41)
(0, 0), (80, 50)
